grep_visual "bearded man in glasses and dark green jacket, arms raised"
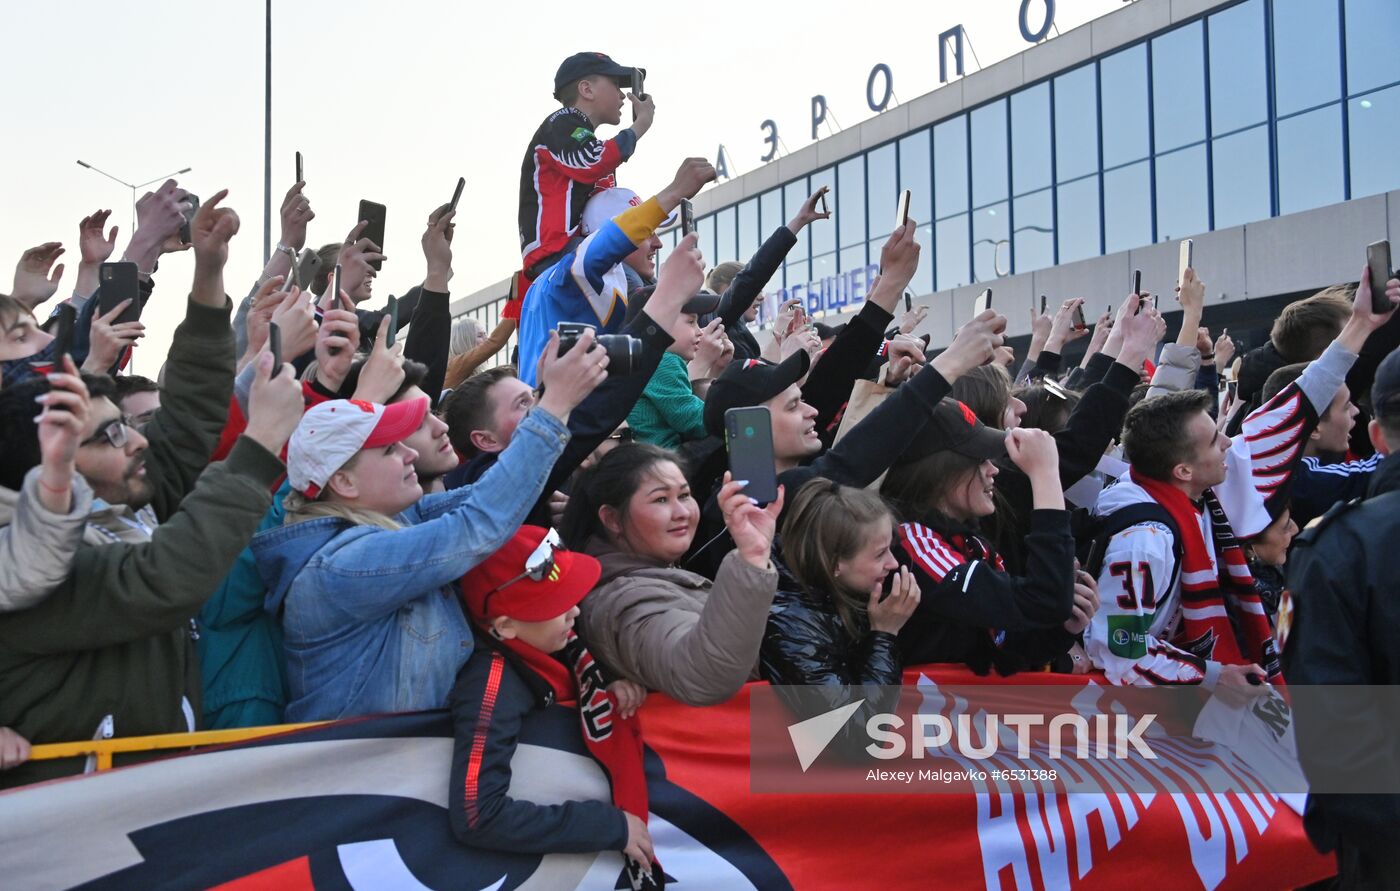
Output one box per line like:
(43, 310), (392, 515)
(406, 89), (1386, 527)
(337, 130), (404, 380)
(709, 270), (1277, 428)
(0, 192), (302, 787)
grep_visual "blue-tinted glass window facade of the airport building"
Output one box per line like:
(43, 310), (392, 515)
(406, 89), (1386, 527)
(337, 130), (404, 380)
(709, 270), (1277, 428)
(662, 0), (1400, 294)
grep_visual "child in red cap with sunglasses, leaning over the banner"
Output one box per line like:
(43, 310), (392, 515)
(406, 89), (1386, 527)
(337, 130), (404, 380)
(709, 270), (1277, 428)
(448, 525), (662, 887)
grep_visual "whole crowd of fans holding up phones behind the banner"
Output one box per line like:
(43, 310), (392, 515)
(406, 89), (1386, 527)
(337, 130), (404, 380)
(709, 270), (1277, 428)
(0, 53), (1400, 883)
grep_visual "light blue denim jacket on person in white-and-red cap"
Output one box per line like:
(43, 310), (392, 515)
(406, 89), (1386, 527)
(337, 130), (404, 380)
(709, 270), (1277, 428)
(252, 409), (568, 721)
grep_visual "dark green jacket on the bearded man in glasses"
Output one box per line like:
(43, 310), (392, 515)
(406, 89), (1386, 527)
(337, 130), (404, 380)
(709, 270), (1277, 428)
(0, 295), (283, 787)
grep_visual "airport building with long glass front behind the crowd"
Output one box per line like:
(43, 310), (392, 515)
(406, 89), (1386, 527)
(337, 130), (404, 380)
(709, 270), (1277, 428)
(454, 0), (1400, 354)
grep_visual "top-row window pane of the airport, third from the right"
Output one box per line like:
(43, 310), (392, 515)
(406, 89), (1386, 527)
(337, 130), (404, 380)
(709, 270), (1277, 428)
(1210, 0), (1268, 135)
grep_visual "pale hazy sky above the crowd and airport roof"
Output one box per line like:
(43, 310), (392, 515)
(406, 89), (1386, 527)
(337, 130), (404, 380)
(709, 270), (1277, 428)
(0, 0), (1124, 377)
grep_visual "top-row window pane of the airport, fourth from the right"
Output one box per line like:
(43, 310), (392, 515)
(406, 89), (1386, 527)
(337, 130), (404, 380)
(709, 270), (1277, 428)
(1152, 21), (1205, 153)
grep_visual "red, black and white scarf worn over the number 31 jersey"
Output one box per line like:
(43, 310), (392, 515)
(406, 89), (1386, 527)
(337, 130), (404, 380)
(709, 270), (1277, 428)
(1133, 472), (1282, 684)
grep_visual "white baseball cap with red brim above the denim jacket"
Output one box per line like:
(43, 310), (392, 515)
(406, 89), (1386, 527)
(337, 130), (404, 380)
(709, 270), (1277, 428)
(287, 396), (428, 499)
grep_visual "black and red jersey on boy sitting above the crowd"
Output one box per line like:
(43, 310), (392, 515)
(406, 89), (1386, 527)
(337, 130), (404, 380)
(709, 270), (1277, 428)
(519, 108), (637, 279)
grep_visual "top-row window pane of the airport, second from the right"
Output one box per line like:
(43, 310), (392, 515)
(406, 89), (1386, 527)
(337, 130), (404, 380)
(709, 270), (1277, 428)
(1274, 0), (1341, 118)
